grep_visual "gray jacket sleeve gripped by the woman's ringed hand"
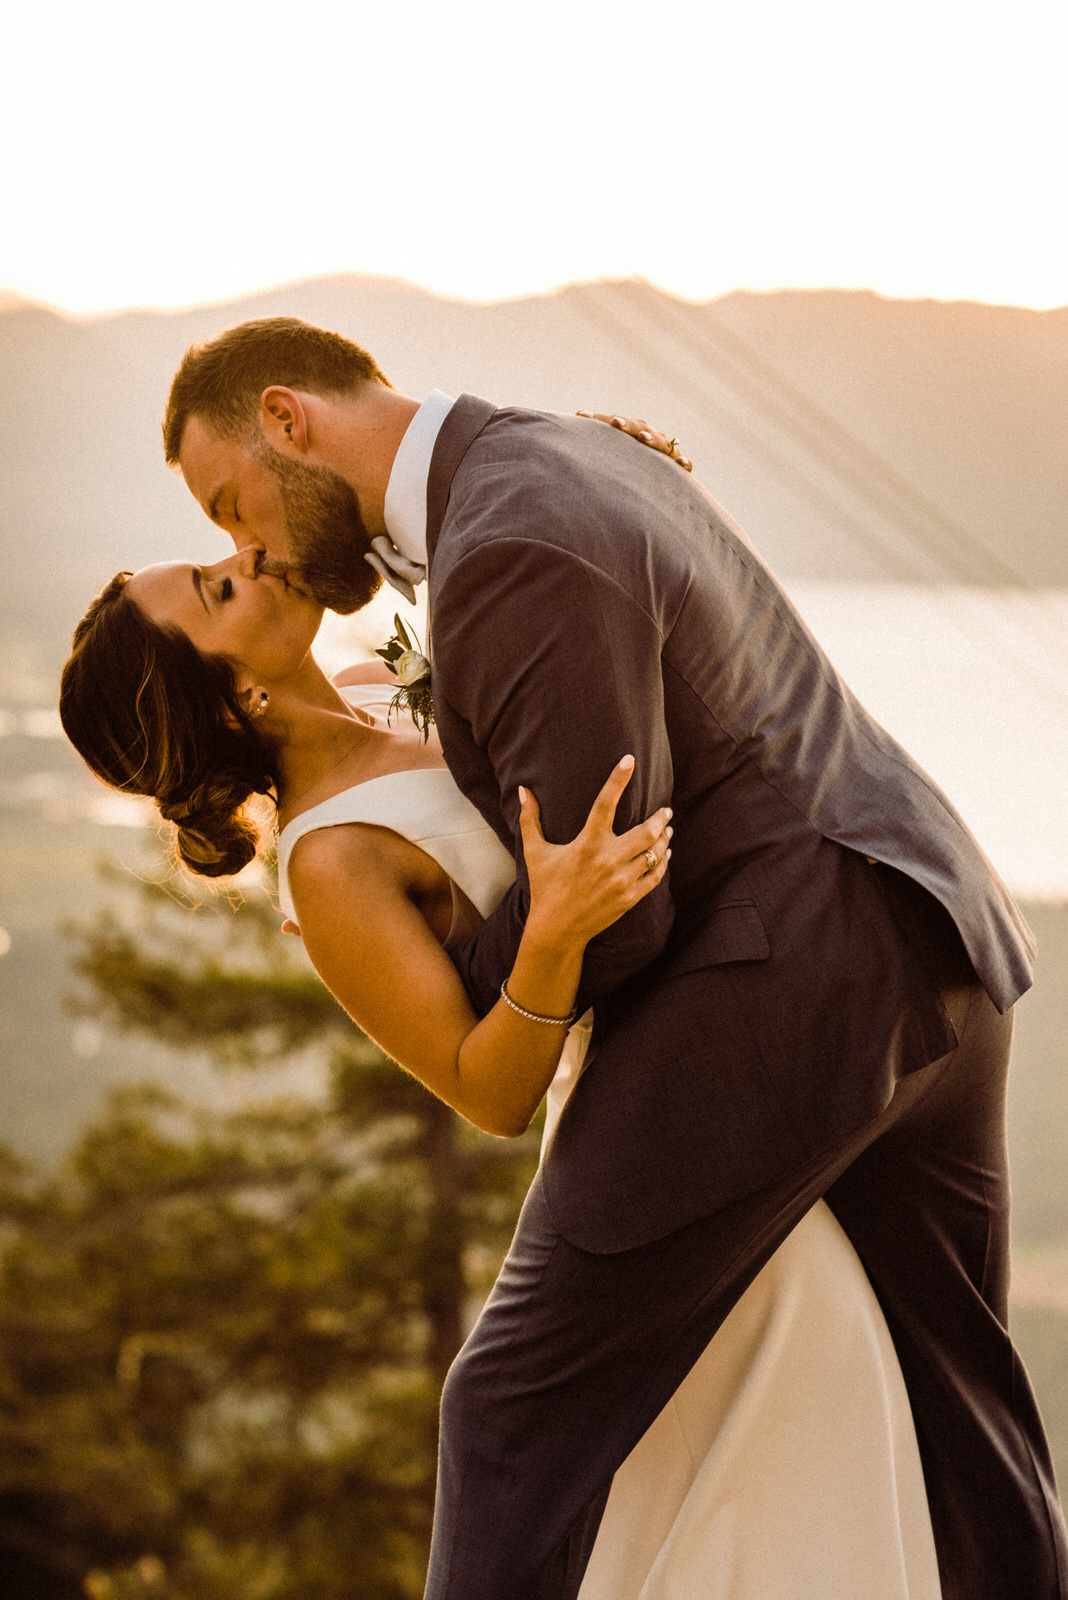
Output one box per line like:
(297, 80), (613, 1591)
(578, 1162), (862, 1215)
(433, 538), (673, 1014)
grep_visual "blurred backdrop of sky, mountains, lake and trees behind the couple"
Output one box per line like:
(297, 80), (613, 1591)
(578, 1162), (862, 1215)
(0, 0), (1068, 1600)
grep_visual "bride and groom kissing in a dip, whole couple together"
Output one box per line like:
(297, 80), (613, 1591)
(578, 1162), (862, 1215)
(61, 318), (1068, 1600)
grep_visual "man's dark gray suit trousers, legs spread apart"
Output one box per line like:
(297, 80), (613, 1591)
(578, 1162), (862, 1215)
(427, 891), (1068, 1600)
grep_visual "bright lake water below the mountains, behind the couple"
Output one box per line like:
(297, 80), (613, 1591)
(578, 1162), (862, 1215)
(320, 582), (1068, 899)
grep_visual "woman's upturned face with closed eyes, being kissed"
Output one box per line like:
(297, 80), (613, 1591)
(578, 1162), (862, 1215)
(126, 546), (323, 686)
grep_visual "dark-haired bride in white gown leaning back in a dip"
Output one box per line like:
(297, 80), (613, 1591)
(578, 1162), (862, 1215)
(61, 528), (940, 1600)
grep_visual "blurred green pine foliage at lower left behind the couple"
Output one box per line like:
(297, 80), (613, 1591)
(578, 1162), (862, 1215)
(0, 864), (536, 1600)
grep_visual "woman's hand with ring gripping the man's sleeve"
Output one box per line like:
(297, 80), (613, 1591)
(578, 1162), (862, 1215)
(520, 755), (671, 949)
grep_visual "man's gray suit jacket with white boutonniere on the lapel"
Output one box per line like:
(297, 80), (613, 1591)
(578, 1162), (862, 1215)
(427, 395), (1034, 1251)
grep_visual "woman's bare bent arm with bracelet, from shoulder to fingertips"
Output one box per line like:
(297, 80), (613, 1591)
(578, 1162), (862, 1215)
(282, 763), (670, 1136)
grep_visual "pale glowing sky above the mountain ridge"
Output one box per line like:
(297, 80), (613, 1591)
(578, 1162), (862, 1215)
(0, 0), (1068, 312)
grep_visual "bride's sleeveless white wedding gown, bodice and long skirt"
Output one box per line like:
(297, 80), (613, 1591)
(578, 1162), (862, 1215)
(278, 685), (942, 1600)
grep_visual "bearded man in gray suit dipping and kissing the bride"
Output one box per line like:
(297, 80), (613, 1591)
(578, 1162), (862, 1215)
(165, 318), (1068, 1600)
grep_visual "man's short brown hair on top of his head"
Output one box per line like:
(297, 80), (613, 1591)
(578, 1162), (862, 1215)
(163, 317), (393, 466)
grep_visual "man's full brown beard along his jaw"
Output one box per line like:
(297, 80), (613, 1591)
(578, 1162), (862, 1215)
(262, 445), (382, 616)
